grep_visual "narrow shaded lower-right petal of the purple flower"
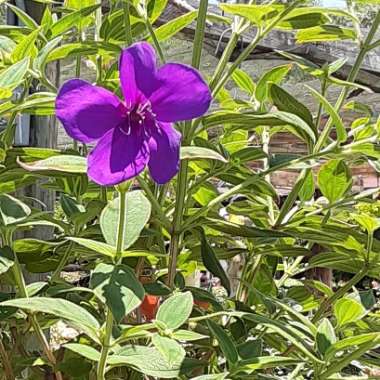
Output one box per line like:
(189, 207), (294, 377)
(148, 123), (181, 184)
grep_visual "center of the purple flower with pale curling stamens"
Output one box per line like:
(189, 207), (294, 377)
(119, 100), (155, 136)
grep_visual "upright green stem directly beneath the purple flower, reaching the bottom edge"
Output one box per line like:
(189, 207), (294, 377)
(96, 188), (127, 380)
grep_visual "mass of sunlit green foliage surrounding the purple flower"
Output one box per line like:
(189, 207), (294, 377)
(0, 0), (380, 380)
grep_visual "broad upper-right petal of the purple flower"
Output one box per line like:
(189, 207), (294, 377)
(149, 63), (211, 122)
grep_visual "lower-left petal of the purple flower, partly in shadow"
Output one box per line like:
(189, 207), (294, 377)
(88, 128), (149, 186)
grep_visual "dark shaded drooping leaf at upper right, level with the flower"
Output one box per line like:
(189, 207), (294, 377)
(269, 83), (316, 131)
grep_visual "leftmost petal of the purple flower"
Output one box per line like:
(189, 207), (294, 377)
(55, 79), (123, 143)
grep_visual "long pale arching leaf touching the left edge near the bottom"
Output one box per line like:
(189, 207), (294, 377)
(0, 297), (100, 342)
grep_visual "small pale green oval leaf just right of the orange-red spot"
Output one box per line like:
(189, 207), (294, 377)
(156, 292), (193, 330)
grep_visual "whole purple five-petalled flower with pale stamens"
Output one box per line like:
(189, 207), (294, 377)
(56, 42), (211, 185)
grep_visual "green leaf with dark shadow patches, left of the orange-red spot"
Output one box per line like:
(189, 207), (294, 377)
(90, 263), (145, 322)
